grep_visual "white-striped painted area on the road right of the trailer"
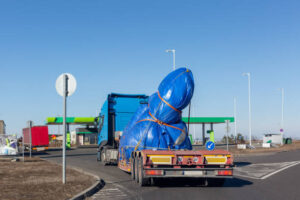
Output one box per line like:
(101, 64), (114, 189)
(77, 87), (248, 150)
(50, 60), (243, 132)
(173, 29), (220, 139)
(234, 161), (300, 180)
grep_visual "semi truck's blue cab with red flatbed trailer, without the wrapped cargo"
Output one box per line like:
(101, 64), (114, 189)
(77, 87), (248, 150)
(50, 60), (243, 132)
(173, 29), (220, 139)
(97, 93), (233, 186)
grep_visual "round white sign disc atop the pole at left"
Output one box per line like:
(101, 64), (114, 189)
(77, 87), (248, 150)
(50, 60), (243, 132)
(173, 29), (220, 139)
(55, 73), (77, 96)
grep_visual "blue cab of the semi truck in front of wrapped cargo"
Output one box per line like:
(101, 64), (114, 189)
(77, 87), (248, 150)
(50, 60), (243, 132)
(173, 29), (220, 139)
(97, 93), (148, 165)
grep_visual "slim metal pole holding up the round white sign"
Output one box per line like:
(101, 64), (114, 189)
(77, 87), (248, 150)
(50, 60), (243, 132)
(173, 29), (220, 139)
(62, 75), (68, 184)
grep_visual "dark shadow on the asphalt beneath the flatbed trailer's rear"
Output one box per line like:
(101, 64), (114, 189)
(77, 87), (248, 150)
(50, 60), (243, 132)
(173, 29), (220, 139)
(155, 177), (253, 188)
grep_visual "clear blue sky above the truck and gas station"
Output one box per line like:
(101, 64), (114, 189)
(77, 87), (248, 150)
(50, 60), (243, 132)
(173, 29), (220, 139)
(0, 0), (300, 139)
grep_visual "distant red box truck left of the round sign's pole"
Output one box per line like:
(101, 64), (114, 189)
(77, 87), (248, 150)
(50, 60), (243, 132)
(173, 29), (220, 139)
(23, 126), (49, 151)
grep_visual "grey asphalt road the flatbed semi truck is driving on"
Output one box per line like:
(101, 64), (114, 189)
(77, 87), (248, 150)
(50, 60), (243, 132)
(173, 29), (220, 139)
(40, 148), (300, 200)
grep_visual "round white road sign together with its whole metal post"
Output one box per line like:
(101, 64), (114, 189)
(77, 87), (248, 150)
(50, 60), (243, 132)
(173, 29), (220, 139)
(56, 73), (76, 184)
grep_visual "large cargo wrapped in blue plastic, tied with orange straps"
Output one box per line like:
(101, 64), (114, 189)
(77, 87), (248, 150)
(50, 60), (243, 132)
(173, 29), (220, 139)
(119, 68), (194, 162)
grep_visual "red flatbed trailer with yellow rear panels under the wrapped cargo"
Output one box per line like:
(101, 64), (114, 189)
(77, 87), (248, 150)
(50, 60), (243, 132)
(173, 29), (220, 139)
(118, 150), (233, 186)
